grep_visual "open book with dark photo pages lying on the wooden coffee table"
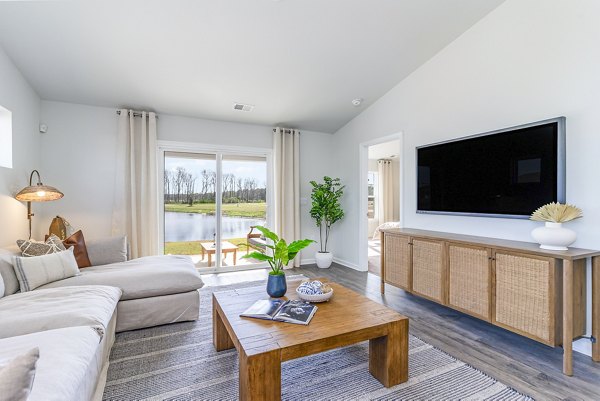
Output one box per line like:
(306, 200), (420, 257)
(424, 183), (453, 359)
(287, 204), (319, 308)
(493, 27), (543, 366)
(240, 298), (317, 325)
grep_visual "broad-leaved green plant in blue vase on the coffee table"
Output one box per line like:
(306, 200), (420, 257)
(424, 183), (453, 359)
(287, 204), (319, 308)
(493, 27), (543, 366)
(242, 226), (316, 298)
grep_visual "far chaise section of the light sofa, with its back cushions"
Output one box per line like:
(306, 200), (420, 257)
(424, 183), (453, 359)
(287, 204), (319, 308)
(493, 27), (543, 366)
(0, 238), (203, 332)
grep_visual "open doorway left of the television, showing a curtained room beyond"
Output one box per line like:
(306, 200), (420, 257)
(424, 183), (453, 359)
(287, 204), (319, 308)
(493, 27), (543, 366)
(359, 134), (402, 275)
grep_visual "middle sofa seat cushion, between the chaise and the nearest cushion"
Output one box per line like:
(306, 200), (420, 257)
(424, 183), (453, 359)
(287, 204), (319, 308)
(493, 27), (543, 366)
(0, 286), (121, 338)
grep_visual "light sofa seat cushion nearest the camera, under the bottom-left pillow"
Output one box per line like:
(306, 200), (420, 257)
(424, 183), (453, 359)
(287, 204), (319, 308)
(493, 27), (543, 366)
(0, 326), (100, 401)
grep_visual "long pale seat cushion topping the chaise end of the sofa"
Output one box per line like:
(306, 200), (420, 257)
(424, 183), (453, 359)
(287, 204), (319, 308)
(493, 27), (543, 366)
(40, 255), (203, 300)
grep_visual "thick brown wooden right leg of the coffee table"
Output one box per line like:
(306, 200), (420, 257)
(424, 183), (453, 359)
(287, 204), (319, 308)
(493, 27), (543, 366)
(369, 320), (408, 387)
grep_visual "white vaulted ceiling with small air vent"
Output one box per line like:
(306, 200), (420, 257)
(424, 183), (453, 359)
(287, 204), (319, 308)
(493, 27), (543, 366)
(0, 0), (502, 132)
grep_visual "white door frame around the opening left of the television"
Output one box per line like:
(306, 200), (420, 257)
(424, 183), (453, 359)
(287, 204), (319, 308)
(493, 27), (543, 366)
(358, 132), (404, 271)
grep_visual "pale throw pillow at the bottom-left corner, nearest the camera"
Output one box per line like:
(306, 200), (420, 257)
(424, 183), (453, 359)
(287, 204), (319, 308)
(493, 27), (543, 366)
(0, 348), (40, 401)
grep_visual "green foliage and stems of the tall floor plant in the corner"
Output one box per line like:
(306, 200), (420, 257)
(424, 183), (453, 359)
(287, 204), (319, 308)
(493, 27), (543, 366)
(310, 176), (345, 252)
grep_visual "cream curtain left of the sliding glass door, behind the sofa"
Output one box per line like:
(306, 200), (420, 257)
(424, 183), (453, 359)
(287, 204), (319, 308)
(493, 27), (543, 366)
(112, 109), (159, 258)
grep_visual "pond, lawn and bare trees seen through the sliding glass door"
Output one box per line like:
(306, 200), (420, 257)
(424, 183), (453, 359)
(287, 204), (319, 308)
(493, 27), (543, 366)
(164, 152), (267, 267)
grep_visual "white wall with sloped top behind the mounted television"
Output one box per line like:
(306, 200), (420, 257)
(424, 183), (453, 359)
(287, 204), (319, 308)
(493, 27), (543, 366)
(333, 0), (600, 353)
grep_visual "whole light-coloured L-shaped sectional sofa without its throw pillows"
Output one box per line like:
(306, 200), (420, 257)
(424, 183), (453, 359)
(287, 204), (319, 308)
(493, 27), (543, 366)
(0, 238), (203, 401)
